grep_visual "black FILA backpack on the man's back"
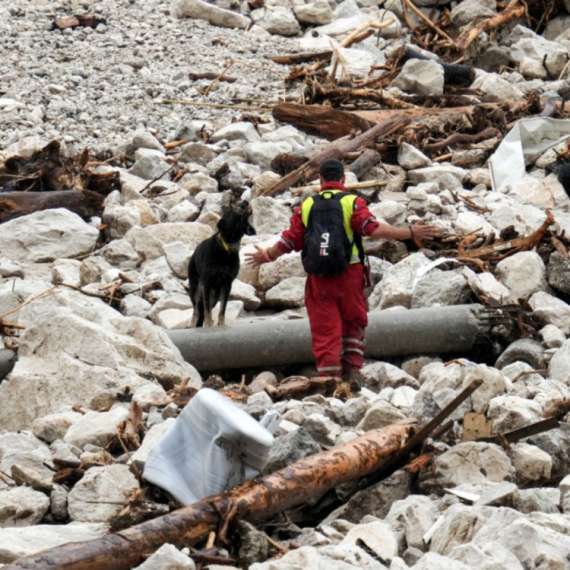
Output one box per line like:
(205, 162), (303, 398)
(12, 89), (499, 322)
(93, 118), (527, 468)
(301, 190), (363, 276)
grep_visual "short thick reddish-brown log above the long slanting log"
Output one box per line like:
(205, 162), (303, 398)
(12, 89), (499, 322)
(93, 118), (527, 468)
(272, 103), (371, 141)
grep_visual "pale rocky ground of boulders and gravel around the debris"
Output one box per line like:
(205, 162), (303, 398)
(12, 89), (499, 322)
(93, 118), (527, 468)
(0, 0), (570, 570)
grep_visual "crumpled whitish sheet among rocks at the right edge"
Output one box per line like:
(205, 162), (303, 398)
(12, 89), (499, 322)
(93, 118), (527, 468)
(489, 117), (570, 190)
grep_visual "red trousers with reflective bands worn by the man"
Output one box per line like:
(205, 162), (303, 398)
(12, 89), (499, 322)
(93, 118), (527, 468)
(305, 263), (368, 376)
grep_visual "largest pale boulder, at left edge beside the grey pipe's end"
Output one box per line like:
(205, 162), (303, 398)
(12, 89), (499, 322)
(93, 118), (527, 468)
(0, 291), (200, 430)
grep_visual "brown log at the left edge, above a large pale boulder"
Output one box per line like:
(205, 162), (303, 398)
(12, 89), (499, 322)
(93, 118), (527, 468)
(0, 190), (104, 223)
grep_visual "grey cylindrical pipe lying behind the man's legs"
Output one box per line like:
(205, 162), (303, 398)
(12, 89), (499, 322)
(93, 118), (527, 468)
(168, 305), (485, 371)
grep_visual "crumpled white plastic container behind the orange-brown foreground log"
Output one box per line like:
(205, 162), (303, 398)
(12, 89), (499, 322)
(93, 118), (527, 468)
(143, 388), (279, 506)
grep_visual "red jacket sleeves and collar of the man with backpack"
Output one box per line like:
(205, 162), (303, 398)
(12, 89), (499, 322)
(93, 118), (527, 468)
(277, 182), (380, 253)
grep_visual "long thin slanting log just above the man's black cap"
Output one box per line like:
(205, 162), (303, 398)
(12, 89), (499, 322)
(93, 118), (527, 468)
(262, 114), (410, 196)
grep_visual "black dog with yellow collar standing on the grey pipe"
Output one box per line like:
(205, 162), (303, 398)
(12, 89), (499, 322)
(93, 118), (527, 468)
(188, 201), (249, 327)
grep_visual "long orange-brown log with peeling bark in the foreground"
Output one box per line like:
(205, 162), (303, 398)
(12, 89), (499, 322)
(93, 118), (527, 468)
(4, 420), (417, 570)
